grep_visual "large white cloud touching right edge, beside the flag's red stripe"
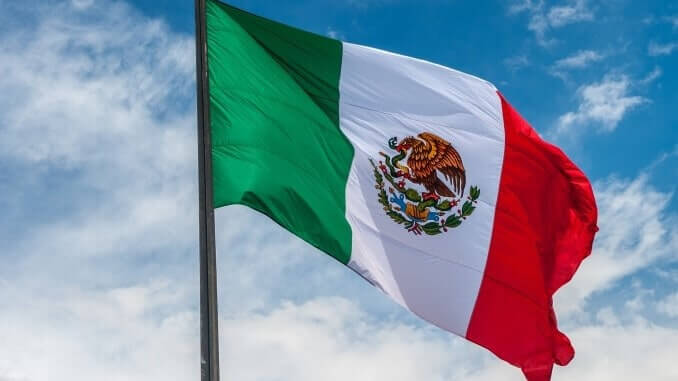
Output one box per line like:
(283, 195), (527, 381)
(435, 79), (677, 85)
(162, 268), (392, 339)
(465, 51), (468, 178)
(555, 176), (678, 315)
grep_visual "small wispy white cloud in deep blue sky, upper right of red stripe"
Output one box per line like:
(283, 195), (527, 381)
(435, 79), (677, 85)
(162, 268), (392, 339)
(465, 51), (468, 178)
(557, 75), (648, 134)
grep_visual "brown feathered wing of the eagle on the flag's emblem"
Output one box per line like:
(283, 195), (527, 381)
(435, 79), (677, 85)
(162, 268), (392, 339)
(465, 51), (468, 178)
(417, 132), (466, 196)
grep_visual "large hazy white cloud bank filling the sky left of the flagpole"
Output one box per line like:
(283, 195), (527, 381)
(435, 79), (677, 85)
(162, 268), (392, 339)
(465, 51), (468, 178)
(0, 1), (199, 381)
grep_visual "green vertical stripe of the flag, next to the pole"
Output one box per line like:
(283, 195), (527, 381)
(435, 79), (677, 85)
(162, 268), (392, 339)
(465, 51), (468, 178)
(207, 0), (353, 263)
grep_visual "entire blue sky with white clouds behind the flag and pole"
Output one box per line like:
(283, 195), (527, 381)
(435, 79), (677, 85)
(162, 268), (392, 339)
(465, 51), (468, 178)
(0, 0), (678, 381)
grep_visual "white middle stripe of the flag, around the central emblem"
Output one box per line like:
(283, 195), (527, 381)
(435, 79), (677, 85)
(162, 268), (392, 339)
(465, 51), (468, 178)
(340, 43), (504, 336)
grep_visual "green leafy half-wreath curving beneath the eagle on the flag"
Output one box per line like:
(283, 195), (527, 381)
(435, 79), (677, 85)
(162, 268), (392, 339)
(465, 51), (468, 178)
(370, 155), (480, 235)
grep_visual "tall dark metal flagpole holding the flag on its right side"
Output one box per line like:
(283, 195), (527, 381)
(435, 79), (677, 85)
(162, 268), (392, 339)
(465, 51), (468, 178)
(195, 0), (219, 381)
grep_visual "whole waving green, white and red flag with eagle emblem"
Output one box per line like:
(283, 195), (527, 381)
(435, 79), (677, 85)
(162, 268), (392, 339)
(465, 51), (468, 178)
(206, 0), (597, 381)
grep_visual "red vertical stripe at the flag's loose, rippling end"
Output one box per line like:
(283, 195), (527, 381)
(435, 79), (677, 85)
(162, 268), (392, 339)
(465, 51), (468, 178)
(466, 94), (598, 381)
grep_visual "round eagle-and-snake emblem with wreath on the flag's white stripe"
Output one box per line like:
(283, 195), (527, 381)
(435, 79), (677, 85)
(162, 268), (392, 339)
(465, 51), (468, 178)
(370, 132), (480, 235)
